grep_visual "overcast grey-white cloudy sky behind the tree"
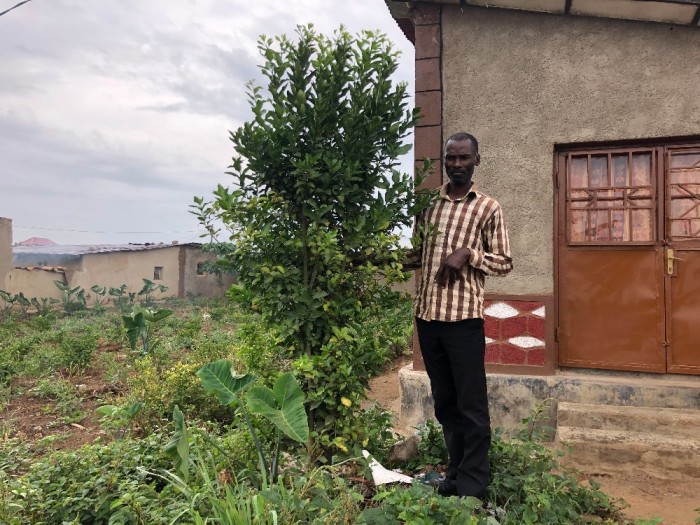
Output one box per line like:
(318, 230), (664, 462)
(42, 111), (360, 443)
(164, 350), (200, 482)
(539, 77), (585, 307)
(0, 0), (413, 244)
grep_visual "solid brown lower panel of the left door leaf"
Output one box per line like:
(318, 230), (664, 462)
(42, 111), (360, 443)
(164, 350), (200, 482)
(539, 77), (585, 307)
(559, 248), (666, 372)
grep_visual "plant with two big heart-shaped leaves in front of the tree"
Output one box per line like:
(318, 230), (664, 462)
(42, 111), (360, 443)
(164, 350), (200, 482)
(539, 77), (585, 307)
(197, 359), (309, 486)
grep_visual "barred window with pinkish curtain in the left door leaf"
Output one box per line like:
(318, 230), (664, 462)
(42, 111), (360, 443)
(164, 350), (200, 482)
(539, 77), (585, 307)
(566, 148), (656, 244)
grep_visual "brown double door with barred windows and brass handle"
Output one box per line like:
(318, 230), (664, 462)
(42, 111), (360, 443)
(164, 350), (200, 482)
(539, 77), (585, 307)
(557, 143), (700, 374)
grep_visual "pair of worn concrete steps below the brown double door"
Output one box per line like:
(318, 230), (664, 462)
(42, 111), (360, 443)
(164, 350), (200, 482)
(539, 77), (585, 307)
(555, 402), (700, 478)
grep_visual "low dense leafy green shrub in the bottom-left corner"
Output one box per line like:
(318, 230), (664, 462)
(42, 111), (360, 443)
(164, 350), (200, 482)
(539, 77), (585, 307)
(0, 434), (184, 525)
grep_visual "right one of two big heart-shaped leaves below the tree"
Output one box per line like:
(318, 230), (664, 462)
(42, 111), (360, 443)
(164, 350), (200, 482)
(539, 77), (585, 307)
(247, 373), (309, 443)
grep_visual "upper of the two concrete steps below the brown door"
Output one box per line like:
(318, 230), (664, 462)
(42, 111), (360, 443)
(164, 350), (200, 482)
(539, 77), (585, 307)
(557, 402), (700, 439)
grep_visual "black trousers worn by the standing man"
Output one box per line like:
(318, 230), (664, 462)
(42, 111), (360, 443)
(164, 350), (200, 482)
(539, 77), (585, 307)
(416, 318), (491, 497)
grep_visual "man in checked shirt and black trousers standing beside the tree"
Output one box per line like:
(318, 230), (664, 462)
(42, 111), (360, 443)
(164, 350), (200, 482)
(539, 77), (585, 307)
(414, 133), (513, 498)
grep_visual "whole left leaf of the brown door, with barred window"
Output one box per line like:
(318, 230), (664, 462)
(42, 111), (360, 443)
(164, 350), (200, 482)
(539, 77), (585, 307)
(558, 148), (666, 372)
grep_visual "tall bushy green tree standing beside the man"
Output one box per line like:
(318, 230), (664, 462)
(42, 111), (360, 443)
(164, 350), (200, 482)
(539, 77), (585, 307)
(192, 27), (430, 452)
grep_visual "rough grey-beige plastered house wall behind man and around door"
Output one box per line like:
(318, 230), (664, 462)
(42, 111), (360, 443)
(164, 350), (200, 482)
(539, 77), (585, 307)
(441, 5), (700, 294)
